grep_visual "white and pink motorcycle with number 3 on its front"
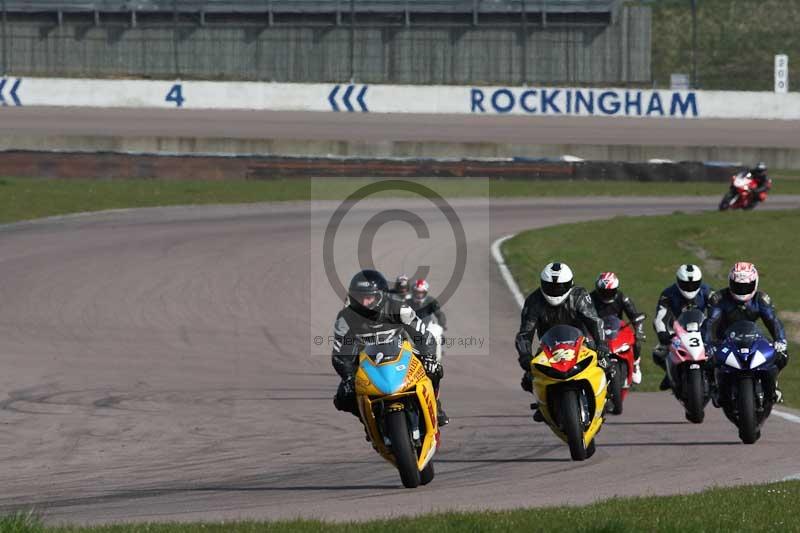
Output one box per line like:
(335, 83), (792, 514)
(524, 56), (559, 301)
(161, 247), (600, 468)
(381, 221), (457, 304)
(667, 309), (713, 424)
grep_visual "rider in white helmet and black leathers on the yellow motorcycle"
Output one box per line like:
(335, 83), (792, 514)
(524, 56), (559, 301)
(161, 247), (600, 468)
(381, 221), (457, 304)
(515, 262), (613, 421)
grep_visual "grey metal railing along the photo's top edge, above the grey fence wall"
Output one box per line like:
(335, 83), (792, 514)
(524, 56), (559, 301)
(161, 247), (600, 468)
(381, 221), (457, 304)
(0, 0), (619, 14)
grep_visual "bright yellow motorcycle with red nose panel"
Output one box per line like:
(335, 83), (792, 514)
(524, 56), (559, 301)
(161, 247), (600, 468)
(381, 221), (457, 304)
(531, 325), (608, 461)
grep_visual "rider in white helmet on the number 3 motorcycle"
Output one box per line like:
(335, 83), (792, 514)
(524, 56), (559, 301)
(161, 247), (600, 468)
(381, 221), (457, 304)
(653, 264), (714, 390)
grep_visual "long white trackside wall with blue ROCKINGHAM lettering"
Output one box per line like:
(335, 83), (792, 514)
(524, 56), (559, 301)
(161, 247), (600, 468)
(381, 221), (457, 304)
(0, 78), (800, 120)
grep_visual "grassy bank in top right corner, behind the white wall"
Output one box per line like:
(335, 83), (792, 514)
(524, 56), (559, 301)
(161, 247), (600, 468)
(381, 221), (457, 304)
(652, 0), (800, 91)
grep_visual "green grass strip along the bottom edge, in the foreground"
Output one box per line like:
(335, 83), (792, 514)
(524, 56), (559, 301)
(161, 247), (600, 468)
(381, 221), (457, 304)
(0, 481), (800, 533)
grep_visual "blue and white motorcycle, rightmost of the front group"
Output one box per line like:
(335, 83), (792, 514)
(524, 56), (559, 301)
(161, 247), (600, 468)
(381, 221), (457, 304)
(716, 321), (778, 444)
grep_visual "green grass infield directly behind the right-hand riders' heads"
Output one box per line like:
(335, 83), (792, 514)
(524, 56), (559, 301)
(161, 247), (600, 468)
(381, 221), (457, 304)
(503, 210), (800, 407)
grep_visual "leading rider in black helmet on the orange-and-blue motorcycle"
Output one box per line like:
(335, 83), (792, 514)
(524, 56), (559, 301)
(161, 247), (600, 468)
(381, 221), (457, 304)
(331, 270), (449, 426)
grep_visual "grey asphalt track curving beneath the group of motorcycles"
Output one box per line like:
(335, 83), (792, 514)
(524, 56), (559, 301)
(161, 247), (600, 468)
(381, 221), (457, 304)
(0, 195), (800, 523)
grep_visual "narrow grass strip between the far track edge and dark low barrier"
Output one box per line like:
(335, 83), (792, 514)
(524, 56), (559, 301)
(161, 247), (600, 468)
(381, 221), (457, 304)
(0, 178), (800, 222)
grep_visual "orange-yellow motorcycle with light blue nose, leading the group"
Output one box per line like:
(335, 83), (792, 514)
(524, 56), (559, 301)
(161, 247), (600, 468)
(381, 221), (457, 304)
(356, 330), (440, 488)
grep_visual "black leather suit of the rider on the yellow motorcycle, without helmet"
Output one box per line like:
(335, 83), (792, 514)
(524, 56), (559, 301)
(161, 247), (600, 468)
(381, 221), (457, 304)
(515, 287), (608, 374)
